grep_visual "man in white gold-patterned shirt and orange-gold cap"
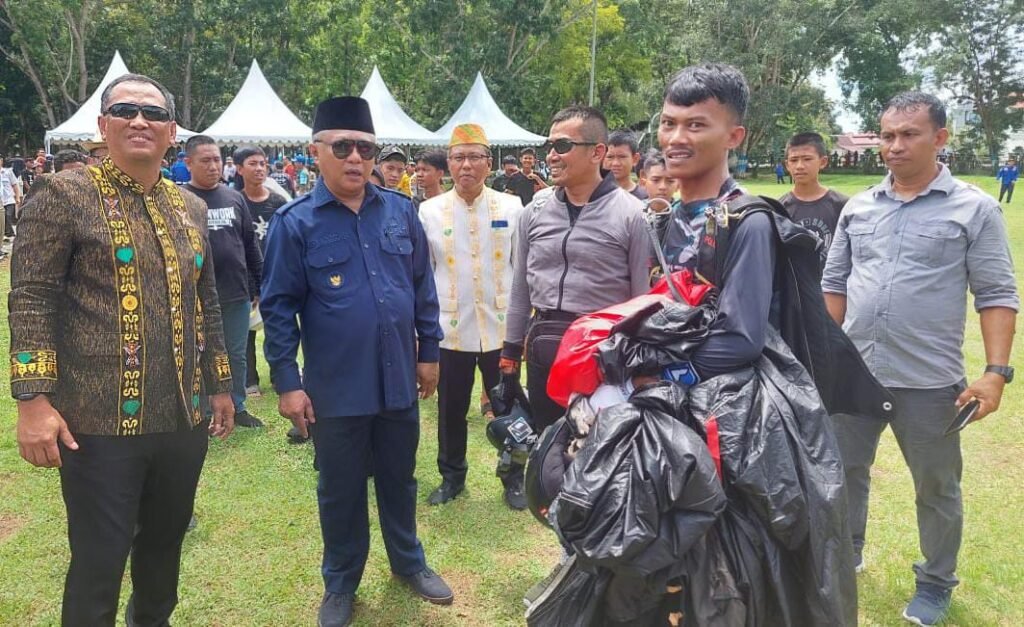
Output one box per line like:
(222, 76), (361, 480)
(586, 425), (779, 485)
(420, 124), (526, 509)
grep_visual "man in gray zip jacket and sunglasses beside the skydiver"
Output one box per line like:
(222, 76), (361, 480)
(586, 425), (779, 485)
(501, 106), (652, 432)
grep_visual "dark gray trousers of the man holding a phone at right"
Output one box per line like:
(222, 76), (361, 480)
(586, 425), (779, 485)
(834, 383), (964, 588)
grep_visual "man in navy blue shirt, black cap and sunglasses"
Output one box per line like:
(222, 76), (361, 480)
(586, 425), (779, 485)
(260, 96), (453, 627)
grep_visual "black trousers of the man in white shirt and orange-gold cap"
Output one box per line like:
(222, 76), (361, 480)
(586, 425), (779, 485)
(437, 348), (502, 486)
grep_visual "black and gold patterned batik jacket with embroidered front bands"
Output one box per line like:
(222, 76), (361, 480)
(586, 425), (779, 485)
(8, 159), (231, 435)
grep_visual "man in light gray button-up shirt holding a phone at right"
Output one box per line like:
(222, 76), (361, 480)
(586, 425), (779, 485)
(822, 92), (1019, 625)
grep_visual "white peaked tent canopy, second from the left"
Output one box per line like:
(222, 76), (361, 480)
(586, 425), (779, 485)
(203, 59), (312, 145)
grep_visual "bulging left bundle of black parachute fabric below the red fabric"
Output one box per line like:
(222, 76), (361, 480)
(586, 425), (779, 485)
(530, 381), (725, 625)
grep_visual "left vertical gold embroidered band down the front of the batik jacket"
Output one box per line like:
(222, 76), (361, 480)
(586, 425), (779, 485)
(89, 159), (145, 435)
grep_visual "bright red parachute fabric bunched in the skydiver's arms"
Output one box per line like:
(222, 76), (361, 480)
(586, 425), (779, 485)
(548, 269), (711, 407)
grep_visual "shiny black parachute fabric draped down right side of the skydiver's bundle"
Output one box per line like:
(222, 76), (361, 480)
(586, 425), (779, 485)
(689, 332), (857, 626)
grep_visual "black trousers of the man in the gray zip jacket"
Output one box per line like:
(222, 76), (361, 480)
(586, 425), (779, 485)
(526, 311), (575, 433)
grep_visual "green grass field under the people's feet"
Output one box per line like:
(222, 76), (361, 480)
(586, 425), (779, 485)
(0, 176), (1024, 627)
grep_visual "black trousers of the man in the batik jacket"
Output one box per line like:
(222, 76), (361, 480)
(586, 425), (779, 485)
(60, 422), (209, 627)
